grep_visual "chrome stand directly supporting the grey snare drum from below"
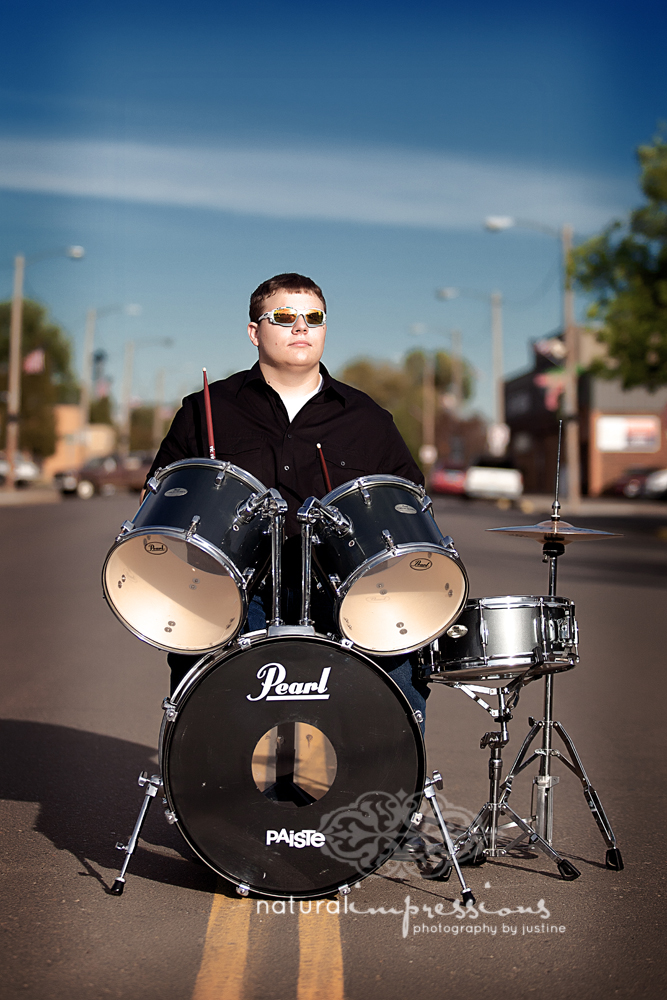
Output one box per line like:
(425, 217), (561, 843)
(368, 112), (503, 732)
(453, 677), (581, 882)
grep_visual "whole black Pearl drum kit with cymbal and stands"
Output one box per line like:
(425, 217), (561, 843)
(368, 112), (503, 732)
(102, 426), (623, 903)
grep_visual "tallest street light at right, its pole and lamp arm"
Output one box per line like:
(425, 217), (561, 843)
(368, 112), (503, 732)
(484, 215), (581, 506)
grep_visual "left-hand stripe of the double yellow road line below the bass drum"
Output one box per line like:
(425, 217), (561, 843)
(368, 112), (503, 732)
(192, 893), (253, 1000)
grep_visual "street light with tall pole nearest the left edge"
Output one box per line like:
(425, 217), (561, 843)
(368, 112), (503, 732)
(5, 246), (85, 490)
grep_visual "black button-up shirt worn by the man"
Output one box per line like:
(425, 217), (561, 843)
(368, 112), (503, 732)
(149, 363), (424, 537)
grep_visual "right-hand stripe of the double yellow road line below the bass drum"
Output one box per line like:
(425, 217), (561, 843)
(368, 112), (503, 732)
(300, 903), (345, 1000)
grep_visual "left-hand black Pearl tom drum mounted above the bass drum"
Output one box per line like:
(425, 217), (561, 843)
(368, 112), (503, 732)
(102, 458), (271, 653)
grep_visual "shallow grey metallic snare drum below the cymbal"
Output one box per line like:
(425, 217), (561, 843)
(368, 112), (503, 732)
(425, 597), (579, 684)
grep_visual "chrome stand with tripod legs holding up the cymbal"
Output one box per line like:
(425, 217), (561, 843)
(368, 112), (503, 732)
(500, 508), (623, 871)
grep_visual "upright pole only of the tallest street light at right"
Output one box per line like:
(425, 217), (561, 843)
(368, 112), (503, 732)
(561, 225), (581, 506)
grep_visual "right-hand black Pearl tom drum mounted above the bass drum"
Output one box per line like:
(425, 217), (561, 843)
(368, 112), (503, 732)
(313, 476), (468, 655)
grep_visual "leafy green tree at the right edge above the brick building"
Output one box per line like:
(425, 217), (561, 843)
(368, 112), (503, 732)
(572, 136), (667, 391)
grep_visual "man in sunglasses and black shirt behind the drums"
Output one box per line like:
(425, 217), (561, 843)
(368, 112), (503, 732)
(149, 274), (428, 714)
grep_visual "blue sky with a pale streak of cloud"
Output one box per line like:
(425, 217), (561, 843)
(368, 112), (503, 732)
(0, 0), (667, 412)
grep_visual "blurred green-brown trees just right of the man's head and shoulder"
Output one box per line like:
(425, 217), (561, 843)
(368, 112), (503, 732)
(340, 350), (473, 458)
